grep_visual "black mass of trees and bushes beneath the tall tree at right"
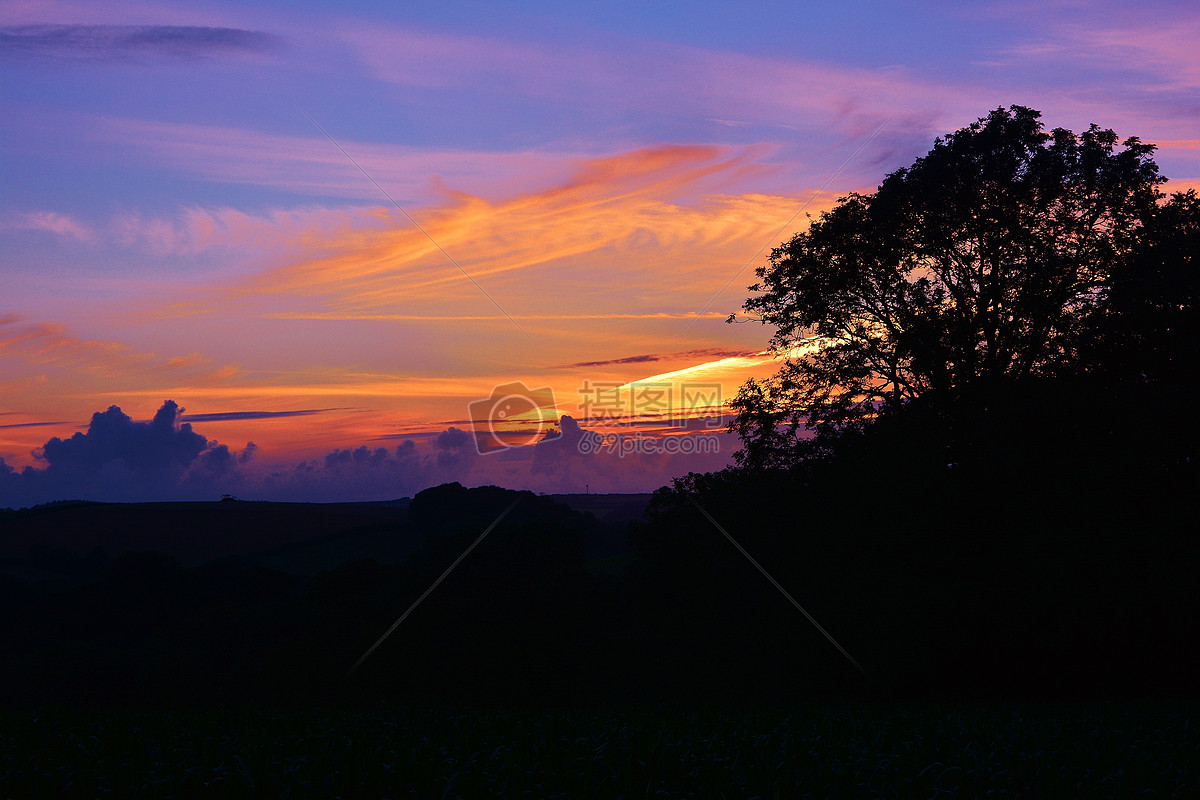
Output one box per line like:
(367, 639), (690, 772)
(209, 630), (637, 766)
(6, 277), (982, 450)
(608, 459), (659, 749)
(638, 397), (1200, 698)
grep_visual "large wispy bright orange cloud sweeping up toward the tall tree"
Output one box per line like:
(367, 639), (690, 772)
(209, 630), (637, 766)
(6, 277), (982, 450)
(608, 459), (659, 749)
(98, 145), (820, 335)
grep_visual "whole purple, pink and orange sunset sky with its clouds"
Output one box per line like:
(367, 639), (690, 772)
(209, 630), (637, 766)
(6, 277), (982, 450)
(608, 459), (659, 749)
(0, 0), (1200, 507)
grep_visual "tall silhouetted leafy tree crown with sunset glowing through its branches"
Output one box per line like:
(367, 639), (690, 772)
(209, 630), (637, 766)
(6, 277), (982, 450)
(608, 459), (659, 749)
(732, 106), (1166, 468)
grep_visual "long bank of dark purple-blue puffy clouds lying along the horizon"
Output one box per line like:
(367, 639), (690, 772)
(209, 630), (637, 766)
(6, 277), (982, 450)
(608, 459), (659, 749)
(0, 401), (737, 507)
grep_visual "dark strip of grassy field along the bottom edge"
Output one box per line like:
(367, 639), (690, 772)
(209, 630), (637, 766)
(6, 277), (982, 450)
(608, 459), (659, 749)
(0, 704), (1200, 800)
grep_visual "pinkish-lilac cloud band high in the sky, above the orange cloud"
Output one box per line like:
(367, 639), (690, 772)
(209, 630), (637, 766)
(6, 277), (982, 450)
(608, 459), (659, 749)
(338, 25), (964, 133)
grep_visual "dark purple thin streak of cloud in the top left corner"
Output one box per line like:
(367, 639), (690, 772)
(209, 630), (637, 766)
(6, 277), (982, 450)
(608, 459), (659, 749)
(0, 24), (283, 64)
